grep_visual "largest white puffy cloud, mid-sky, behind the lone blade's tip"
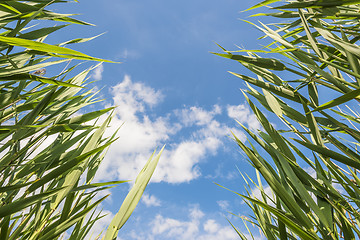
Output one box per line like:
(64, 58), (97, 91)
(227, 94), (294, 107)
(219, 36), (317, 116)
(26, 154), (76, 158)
(97, 76), (256, 183)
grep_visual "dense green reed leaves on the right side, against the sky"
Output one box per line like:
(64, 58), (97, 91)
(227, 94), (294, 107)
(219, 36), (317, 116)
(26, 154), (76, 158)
(218, 0), (360, 239)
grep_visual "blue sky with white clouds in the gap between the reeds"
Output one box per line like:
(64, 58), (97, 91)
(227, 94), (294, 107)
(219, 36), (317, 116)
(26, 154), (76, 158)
(50, 0), (272, 240)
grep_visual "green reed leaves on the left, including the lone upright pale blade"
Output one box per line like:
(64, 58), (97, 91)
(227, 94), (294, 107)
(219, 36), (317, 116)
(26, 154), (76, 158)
(0, 0), (160, 240)
